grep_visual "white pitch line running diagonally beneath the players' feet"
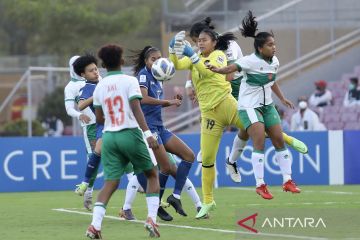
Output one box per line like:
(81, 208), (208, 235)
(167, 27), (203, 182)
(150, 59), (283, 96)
(52, 208), (327, 240)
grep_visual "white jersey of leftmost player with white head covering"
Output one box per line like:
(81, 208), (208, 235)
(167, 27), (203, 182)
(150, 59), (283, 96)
(64, 79), (96, 126)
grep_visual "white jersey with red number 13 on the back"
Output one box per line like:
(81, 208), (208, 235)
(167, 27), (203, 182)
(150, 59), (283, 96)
(93, 71), (142, 132)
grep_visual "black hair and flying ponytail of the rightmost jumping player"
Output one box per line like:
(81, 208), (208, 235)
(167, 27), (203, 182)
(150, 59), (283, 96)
(240, 11), (274, 53)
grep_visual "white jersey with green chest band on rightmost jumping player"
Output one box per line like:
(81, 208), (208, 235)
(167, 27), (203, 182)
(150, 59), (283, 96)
(235, 53), (279, 110)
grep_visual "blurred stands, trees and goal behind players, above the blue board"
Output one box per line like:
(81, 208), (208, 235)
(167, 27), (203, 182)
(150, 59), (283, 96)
(0, 0), (360, 136)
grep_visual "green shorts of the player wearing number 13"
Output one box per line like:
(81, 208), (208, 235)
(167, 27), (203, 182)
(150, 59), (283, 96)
(101, 128), (156, 180)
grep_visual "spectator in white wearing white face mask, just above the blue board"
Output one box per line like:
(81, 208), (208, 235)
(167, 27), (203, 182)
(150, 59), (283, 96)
(290, 97), (326, 131)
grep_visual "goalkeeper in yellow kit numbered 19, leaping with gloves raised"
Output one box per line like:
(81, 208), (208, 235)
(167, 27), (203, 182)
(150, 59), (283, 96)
(169, 29), (308, 219)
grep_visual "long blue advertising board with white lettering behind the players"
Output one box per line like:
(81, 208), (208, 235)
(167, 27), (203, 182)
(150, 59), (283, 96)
(0, 132), (332, 192)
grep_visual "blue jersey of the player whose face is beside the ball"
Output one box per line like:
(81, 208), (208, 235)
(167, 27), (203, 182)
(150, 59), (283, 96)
(136, 67), (163, 126)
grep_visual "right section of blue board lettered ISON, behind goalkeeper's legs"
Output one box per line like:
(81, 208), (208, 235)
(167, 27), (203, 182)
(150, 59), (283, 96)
(176, 132), (329, 187)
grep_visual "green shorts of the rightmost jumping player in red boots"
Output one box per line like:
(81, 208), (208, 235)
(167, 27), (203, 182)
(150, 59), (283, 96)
(239, 104), (281, 129)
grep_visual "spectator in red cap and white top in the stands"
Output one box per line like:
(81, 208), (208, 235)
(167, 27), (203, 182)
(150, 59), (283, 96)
(309, 80), (332, 107)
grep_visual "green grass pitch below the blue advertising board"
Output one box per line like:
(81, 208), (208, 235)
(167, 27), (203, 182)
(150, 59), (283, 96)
(0, 185), (360, 240)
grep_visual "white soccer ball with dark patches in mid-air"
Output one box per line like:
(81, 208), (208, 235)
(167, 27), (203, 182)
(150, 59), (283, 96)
(151, 58), (175, 81)
